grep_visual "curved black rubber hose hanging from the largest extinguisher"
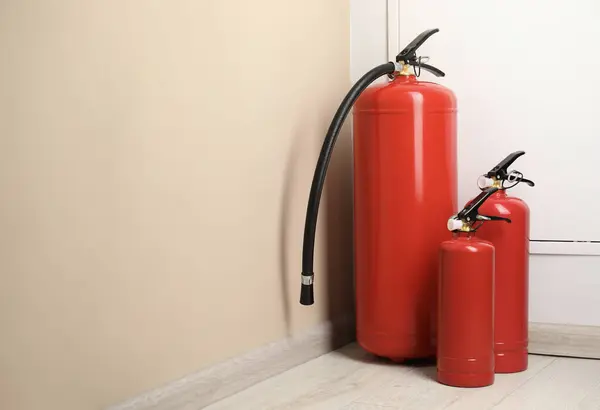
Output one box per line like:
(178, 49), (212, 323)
(300, 62), (396, 305)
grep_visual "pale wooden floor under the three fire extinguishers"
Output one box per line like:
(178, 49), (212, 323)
(206, 344), (600, 410)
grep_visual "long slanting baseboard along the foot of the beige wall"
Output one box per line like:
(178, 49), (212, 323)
(106, 318), (355, 410)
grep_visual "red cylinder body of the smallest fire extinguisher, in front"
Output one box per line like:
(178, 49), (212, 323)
(437, 234), (494, 387)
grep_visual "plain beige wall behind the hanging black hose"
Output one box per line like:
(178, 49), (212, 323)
(0, 0), (352, 410)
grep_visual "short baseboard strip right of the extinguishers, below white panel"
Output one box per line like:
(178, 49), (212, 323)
(529, 323), (600, 359)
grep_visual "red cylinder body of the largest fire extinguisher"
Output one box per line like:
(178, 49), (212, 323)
(354, 76), (457, 361)
